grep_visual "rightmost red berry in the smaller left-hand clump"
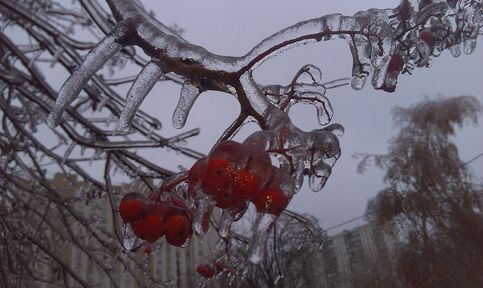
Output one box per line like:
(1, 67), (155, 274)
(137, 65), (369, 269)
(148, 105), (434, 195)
(165, 208), (192, 246)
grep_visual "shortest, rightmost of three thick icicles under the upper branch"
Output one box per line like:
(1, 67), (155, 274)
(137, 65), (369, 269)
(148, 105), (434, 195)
(173, 81), (201, 129)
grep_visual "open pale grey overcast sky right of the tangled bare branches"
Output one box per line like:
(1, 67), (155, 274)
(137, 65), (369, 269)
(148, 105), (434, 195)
(133, 0), (483, 232)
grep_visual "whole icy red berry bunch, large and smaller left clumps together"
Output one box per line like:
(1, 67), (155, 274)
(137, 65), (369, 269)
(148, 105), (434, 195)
(119, 141), (294, 246)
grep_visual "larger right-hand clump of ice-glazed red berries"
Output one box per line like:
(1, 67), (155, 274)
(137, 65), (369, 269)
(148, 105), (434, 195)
(188, 141), (291, 216)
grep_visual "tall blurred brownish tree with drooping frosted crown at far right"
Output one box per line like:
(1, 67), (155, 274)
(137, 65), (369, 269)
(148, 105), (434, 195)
(359, 96), (483, 287)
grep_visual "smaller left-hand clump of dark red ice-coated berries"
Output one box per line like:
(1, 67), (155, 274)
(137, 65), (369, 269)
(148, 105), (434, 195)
(119, 192), (192, 246)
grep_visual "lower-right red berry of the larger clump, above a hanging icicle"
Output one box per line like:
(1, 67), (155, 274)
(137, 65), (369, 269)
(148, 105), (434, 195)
(252, 187), (289, 216)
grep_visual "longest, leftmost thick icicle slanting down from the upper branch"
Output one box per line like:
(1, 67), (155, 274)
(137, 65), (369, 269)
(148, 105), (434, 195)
(47, 34), (122, 127)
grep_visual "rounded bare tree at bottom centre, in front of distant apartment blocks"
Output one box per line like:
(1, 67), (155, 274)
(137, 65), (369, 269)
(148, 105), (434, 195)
(214, 212), (327, 287)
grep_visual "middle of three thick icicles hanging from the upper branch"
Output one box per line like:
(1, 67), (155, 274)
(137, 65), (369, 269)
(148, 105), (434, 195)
(119, 60), (164, 128)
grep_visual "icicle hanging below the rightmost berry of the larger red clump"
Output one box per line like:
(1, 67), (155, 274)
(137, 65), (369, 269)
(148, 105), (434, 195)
(248, 213), (277, 264)
